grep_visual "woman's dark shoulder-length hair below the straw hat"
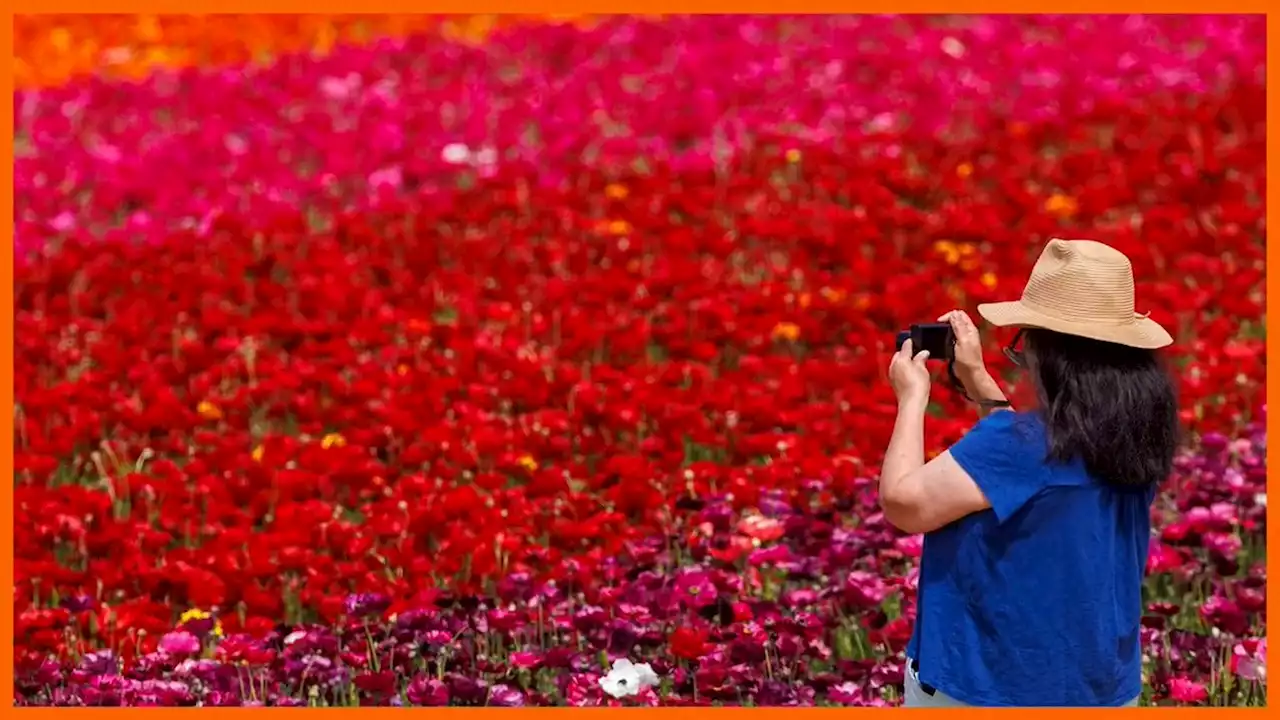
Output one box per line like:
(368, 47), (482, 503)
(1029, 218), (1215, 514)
(1024, 329), (1179, 488)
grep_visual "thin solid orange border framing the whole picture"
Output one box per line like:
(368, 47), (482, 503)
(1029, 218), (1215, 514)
(0, 0), (1280, 720)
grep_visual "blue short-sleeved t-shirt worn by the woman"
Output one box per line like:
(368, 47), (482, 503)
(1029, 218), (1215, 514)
(908, 411), (1156, 707)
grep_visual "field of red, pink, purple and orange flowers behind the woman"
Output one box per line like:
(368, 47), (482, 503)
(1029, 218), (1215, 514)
(13, 15), (1266, 706)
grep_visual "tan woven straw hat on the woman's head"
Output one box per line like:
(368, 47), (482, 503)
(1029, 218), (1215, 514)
(978, 238), (1174, 350)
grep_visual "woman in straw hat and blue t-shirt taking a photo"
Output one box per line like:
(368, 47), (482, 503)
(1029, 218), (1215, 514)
(879, 240), (1178, 707)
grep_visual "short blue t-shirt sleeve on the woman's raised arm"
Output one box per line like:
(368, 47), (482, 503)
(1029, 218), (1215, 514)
(951, 410), (1044, 523)
